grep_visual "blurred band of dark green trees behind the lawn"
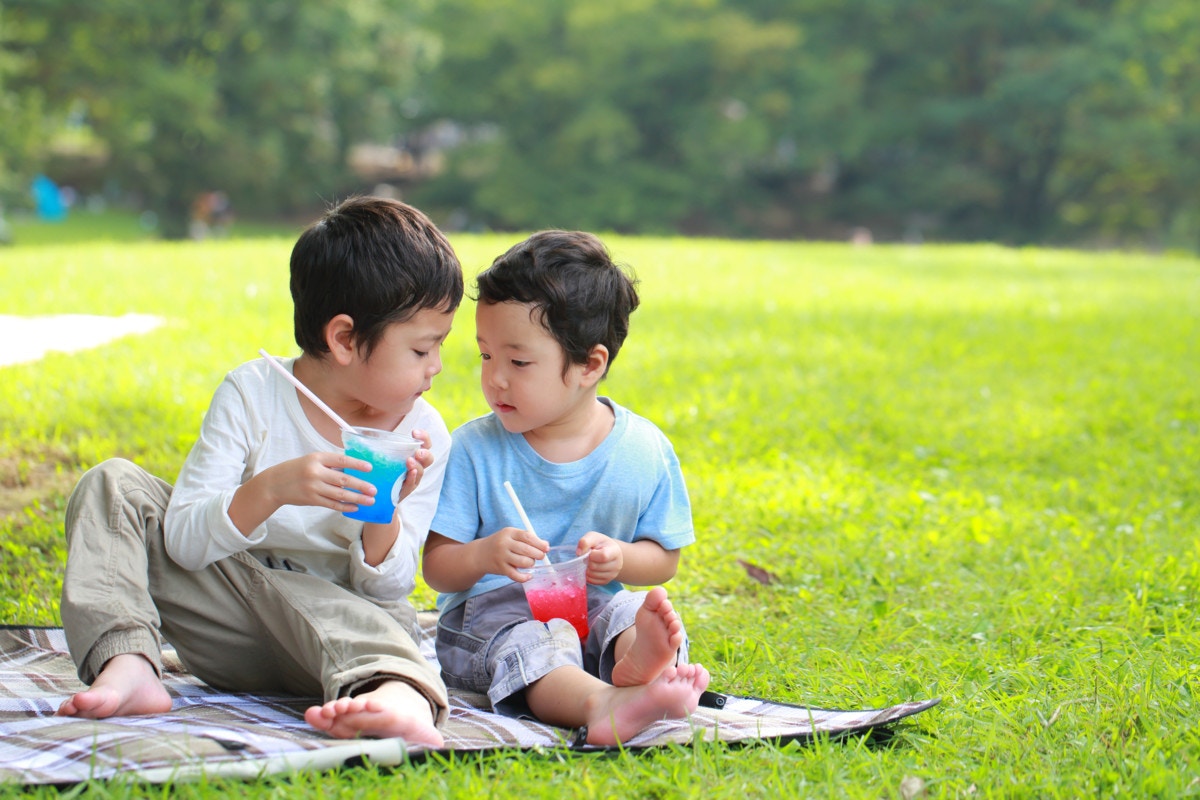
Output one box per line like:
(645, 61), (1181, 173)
(0, 0), (1200, 246)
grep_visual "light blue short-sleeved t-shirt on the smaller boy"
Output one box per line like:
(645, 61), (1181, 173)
(430, 397), (696, 613)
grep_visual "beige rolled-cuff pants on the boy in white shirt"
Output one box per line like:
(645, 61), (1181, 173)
(62, 459), (446, 724)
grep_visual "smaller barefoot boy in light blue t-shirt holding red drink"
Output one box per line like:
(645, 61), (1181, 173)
(422, 230), (708, 745)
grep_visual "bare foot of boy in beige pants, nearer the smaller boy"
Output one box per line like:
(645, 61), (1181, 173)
(304, 680), (445, 747)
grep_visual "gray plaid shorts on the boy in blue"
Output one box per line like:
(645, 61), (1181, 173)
(436, 583), (688, 716)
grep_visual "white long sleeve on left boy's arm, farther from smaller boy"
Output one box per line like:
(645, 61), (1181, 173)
(164, 377), (266, 570)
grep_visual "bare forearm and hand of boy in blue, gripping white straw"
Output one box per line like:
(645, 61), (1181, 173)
(421, 528), (550, 593)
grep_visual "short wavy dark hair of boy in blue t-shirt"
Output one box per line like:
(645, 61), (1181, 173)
(475, 230), (640, 374)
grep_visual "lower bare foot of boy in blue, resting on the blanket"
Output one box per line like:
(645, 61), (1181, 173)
(587, 664), (708, 745)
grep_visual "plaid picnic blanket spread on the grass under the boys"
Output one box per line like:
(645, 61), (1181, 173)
(0, 612), (938, 784)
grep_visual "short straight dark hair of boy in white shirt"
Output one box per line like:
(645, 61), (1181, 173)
(292, 197), (463, 357)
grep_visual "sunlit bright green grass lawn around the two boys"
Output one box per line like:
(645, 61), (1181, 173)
(0, 235), (1200, 798)
